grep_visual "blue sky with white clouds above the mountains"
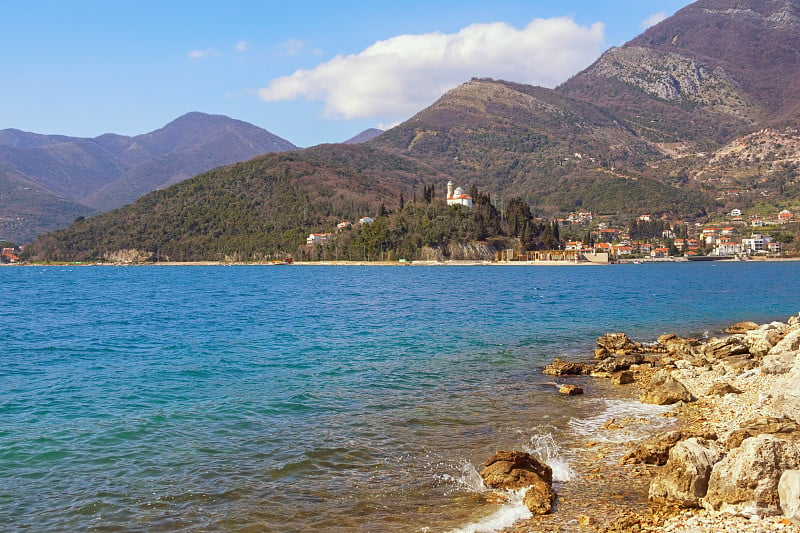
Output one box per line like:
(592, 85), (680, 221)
(0, 0), (691, 147)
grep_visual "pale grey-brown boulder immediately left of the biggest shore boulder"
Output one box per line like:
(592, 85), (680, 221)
(649, 437), (722, 507)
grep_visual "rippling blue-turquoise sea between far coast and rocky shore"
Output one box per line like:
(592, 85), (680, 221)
(0, 261), (800, 532)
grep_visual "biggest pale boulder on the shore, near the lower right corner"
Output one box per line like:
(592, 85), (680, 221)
(702, 435), (800, 517)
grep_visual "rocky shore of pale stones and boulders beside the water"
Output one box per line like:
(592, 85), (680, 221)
(500, 316), (800, 533)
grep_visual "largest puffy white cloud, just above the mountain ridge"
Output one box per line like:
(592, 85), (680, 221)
(259, 18), (605, 119)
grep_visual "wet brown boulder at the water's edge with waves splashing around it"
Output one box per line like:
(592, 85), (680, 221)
(481, 451), (556, 514)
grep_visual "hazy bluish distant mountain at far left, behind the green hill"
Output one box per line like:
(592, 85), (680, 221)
(0, 113), (297, 242)
